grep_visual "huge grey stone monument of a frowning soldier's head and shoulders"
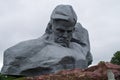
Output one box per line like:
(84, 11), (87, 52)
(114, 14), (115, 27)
(1, 5), (92, 76)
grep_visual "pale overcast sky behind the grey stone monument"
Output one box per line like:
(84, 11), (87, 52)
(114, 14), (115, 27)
(0, 0), (120, 69)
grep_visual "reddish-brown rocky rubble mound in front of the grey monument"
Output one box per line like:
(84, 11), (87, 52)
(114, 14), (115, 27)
(26, 62), (120, 80)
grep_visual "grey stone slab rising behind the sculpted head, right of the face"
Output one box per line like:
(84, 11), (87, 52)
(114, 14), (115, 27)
(71, 23), (92, 65)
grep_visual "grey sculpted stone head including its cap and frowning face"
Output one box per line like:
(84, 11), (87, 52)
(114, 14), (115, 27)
(46, 5), (77, 47)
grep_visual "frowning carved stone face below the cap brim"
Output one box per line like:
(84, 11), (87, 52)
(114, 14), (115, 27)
(52, 20), (74, 47)
